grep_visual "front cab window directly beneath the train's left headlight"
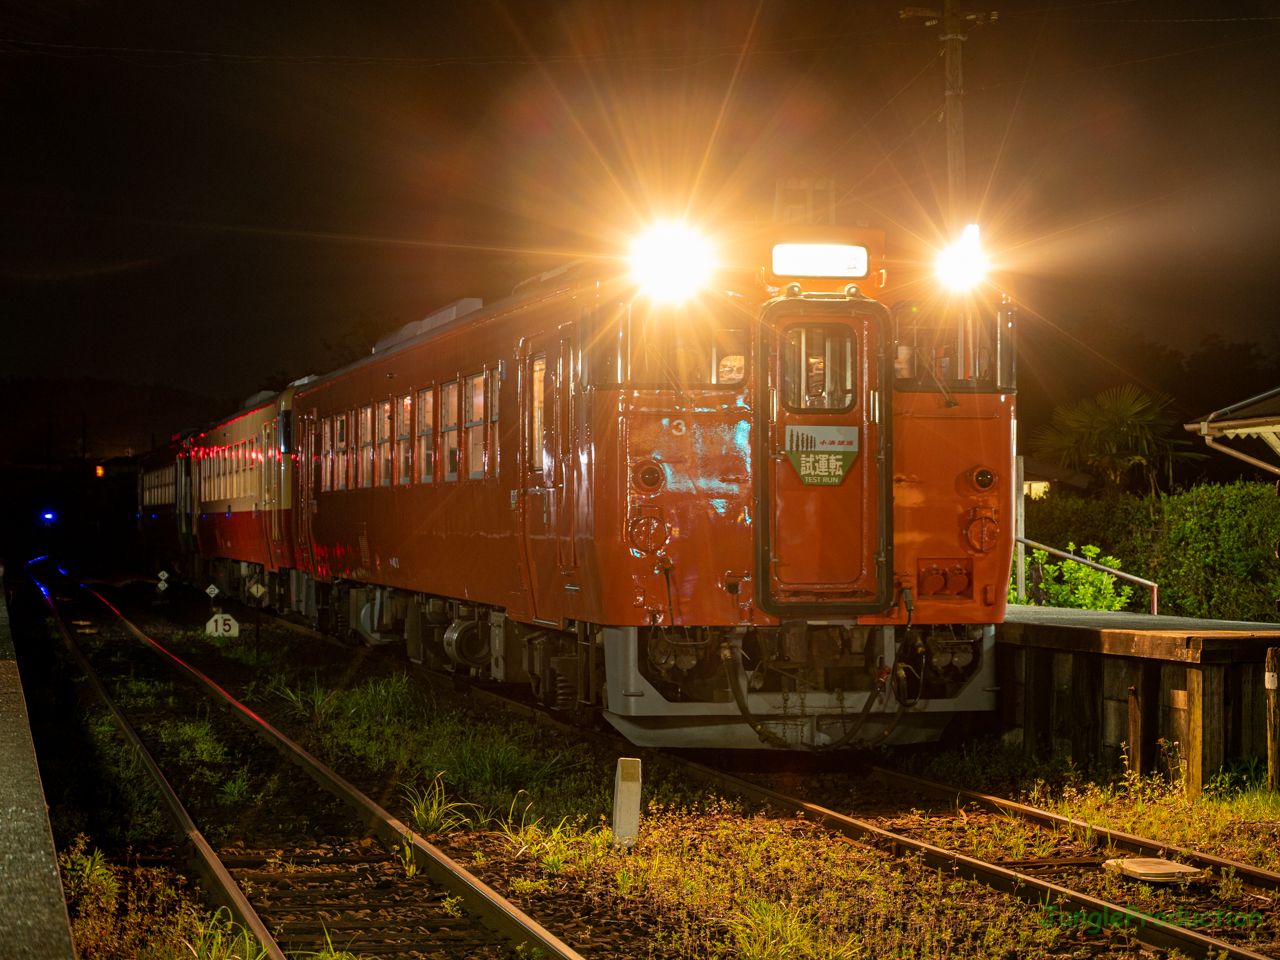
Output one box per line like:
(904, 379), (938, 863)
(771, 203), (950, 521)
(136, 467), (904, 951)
(588, 297), (750, 389)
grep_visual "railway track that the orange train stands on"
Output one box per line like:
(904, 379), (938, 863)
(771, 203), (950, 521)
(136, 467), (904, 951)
(77, 578), (1280, 960)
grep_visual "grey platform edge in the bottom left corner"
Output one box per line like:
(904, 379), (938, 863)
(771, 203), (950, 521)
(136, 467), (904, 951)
(0, 568), (76, 960)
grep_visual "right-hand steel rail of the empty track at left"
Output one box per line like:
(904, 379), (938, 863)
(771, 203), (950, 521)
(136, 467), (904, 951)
(81, 584), (584, 960)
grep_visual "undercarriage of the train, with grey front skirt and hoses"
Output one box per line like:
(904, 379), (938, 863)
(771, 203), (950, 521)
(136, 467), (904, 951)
(188, 559), (996, 750)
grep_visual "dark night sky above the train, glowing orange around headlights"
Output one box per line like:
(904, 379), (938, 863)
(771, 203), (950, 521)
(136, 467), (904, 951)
(0, 0), (1280, 419)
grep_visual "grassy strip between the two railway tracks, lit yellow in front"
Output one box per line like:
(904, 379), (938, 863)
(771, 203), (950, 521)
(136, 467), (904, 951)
(120, 591), (1162, 960)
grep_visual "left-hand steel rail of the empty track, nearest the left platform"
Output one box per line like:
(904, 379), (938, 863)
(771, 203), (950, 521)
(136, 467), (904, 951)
(31, 575), (285, 960)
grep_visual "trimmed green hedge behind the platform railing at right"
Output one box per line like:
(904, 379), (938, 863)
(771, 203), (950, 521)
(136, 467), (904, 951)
(1027, 481), (1280, 623)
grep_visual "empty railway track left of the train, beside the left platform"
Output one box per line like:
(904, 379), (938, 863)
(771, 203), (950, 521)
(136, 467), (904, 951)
(33, 575), (581, 960)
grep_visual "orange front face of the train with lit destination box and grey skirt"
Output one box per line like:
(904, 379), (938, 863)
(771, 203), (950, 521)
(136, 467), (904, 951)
(604, 227), (1014, 750)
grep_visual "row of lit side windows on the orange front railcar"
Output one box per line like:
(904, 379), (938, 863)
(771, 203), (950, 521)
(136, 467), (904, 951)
(320, 370), (500, 492)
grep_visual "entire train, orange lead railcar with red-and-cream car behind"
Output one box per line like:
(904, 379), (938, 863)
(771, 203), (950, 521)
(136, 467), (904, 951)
(149, 228), (1014, 748)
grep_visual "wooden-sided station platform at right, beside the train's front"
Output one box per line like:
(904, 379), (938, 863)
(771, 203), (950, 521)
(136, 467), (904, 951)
(996, 604), (1280, 795)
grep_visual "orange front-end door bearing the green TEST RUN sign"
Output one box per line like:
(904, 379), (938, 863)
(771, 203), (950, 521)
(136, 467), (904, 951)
(755, 300), (893, 617)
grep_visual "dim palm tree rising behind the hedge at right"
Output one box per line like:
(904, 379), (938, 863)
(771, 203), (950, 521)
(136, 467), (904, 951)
(1032, 384), (1204, 495)
